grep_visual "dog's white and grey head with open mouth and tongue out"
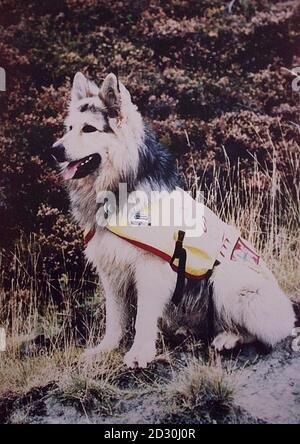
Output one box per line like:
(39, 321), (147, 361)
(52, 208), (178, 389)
(51, 73), (143, 189)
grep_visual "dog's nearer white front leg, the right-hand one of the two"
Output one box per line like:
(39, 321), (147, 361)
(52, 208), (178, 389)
(124, 255), (176, 368)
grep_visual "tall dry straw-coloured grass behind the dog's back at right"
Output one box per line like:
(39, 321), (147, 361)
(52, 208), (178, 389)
(186, 128), (300, 301)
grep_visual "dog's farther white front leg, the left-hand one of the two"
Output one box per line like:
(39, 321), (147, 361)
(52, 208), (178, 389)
(83, 271), (125, 358)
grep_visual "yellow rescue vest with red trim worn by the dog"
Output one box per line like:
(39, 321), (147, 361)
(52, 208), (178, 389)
(85, 188), (269, 279)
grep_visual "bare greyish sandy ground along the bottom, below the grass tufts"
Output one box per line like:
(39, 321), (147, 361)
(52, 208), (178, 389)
(0, 338), (300, 424)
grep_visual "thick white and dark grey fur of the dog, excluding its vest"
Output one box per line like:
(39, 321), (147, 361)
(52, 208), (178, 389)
(54, 73), (295, 367)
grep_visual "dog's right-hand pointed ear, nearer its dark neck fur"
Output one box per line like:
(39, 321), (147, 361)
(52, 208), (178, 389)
(99, 73), (121, 118)
